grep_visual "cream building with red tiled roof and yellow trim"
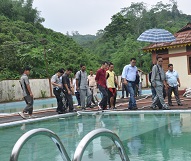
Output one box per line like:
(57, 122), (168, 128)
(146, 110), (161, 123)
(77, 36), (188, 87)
(143, 23), (191, 90)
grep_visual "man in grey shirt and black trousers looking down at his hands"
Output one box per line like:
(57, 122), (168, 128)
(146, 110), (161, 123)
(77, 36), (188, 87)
(51, 69), (64, 114)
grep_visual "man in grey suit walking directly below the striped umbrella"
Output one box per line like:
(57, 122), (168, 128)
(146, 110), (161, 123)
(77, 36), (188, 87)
(151, 57), (170, 110)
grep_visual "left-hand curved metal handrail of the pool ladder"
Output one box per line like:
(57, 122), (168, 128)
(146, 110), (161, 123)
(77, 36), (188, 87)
(10, 128), (71, 161)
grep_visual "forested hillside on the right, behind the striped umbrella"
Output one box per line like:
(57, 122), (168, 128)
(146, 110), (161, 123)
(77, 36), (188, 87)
(71, 0), (191, 74)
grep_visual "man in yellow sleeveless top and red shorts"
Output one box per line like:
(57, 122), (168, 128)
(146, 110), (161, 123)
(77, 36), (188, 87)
(106, 62), (118, 109)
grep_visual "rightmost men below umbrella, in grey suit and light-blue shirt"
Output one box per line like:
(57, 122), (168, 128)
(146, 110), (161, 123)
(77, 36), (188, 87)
(149, 57), (183, 110)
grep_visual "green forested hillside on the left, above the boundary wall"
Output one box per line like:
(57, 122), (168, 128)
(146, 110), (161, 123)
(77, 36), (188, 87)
(0, 0), (99, 80)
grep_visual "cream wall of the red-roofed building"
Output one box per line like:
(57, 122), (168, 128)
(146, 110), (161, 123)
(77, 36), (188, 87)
(169, 56), (191, 90)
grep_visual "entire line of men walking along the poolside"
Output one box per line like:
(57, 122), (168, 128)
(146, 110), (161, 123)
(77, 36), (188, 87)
(19, 57), (182, 118)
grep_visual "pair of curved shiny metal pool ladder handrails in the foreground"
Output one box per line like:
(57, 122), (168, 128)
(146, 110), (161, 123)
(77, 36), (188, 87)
(10, 128), (129, 161)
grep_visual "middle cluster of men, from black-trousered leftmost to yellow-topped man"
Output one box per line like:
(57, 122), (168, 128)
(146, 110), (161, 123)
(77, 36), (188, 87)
(51, 62), (118, 114)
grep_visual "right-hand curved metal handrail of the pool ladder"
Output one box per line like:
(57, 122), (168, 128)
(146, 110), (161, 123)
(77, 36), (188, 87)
(72, 128), (129, 161)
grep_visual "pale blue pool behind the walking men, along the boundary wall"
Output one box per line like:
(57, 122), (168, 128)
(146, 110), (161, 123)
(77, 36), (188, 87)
(0, 90), (151, 113)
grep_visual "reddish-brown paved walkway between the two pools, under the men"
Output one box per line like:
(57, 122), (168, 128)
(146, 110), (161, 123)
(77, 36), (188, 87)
(0, 97), (191, 124)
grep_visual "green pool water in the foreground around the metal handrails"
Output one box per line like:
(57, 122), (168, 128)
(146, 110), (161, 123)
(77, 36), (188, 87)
(0, 113), (191, 161)
